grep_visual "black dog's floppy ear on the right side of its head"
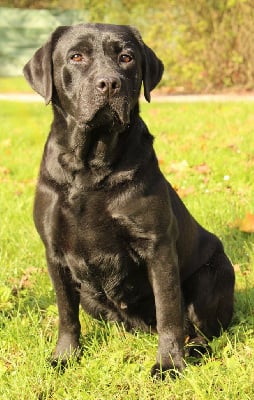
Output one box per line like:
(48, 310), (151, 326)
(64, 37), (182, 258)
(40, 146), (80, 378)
(142, 44), (164, 102)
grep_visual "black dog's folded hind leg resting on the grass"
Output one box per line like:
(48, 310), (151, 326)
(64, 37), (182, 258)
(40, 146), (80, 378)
(182, 251), (235, 354)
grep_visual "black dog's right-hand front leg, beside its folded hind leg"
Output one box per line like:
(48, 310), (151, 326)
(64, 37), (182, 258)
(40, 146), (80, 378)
(149, 243), (184, 379)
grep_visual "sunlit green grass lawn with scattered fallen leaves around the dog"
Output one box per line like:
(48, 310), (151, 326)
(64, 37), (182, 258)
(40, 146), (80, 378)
(0, 102), (254, 400)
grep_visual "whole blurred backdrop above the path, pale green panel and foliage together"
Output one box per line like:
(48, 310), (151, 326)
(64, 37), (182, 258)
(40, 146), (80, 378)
(0, 0), (254, 93)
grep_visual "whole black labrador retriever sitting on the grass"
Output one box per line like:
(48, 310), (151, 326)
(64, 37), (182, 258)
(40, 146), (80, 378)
(24, 24), (234, 376)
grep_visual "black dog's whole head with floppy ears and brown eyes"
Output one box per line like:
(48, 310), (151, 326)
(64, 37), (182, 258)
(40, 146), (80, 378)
(24, 24), (163, 125)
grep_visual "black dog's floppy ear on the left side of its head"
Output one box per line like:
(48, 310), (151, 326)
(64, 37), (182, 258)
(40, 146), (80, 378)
(23, 26), (67, 104)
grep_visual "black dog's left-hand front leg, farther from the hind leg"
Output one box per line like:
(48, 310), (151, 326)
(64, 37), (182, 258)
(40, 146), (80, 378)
(48, 259), (80, 366)
